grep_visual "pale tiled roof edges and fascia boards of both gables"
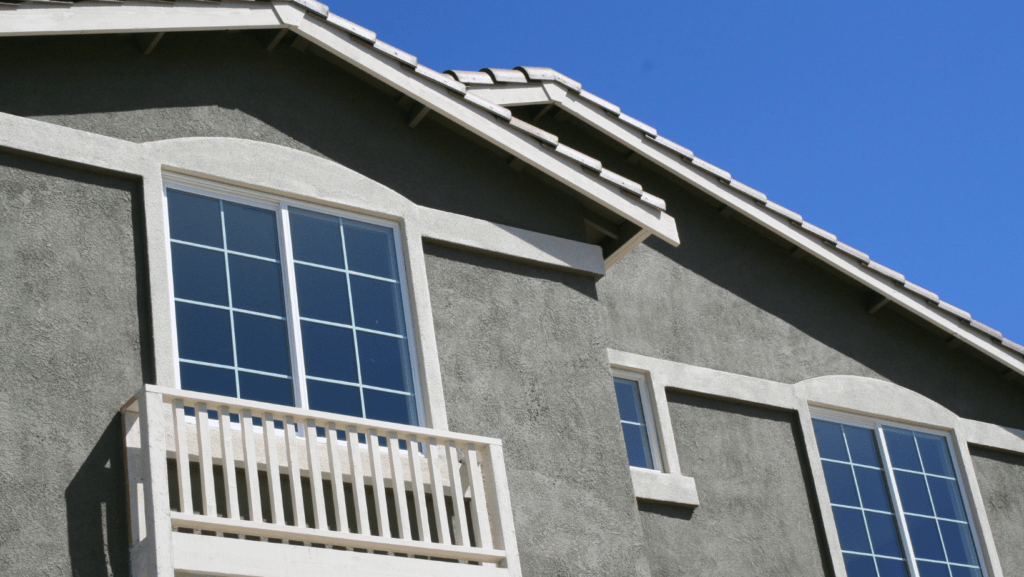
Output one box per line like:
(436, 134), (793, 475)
(0, 0), (1024, 375)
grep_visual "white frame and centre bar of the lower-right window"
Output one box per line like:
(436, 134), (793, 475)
(805, 405), (991, 577)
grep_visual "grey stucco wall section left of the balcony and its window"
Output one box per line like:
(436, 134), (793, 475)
(0, 154), (152, 577)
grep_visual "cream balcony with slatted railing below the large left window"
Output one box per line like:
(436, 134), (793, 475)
(122, 386), (520, 577)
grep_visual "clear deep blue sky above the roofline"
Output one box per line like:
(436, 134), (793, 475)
(330, 0), (1024, 342)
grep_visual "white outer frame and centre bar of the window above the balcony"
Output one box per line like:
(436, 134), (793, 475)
(160, 171), (430, 426)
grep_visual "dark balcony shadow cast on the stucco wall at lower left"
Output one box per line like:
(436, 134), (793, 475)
(65, 413), (131, 577)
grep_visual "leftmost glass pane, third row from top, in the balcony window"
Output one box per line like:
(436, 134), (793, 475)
(174, 302), (234, 366)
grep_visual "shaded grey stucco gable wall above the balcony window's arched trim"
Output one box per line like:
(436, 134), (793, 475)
(0, 31), (585, 240)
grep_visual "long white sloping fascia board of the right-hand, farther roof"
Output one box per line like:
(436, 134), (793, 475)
(545, 83), (1024, 375)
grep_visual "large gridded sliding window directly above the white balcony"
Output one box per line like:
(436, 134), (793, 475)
(165, 184), (420, 424)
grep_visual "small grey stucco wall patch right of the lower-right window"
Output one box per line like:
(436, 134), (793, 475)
(971, 447), (1024, 577)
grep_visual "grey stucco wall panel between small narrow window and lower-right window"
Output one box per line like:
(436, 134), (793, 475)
(640, 393), (831, 577)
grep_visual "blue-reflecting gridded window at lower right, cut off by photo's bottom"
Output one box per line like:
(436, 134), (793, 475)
(813, 418), (983, 577)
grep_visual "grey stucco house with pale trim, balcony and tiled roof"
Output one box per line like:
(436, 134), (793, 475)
(0, 0), (1024, 577)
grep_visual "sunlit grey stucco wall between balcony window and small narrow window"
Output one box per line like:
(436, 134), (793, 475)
(425, 245), (649, 577)
